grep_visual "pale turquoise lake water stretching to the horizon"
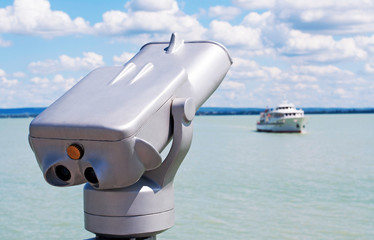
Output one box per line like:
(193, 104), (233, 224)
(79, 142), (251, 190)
(0, 114), (374, 240)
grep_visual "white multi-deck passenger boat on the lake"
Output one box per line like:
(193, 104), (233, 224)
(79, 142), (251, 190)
(257, 102), (306, 133)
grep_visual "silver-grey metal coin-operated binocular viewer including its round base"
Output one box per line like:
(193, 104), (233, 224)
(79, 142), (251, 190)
(29, 34), (232, 238)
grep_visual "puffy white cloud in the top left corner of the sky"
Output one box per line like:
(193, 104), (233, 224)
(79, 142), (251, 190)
(0, 0), (90, 38)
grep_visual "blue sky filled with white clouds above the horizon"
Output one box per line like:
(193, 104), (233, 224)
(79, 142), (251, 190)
(0, 0), (374, 108)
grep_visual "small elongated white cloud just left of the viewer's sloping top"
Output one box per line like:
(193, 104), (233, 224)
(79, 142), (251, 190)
(28, 52), (104, 74)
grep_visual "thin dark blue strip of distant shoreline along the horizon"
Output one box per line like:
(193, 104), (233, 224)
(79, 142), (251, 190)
(0, 107), (374, 118)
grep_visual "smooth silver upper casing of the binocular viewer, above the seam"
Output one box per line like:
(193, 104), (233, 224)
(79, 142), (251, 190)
(30, 34), (231, 141)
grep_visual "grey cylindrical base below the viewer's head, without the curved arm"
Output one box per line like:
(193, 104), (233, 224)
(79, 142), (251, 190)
(84, 178), (174, 239)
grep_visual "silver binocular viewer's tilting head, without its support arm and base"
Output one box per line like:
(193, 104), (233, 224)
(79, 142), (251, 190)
(29, 32), (231, 189)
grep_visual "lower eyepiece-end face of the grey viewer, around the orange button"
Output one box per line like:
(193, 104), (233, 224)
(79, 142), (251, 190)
(32, 138), (162, 189)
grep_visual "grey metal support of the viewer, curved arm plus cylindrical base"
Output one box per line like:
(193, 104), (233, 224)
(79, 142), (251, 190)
(84, 99), (194, 236)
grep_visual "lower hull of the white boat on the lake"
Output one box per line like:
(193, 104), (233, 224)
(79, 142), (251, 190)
(257, 118), (306, 133)
